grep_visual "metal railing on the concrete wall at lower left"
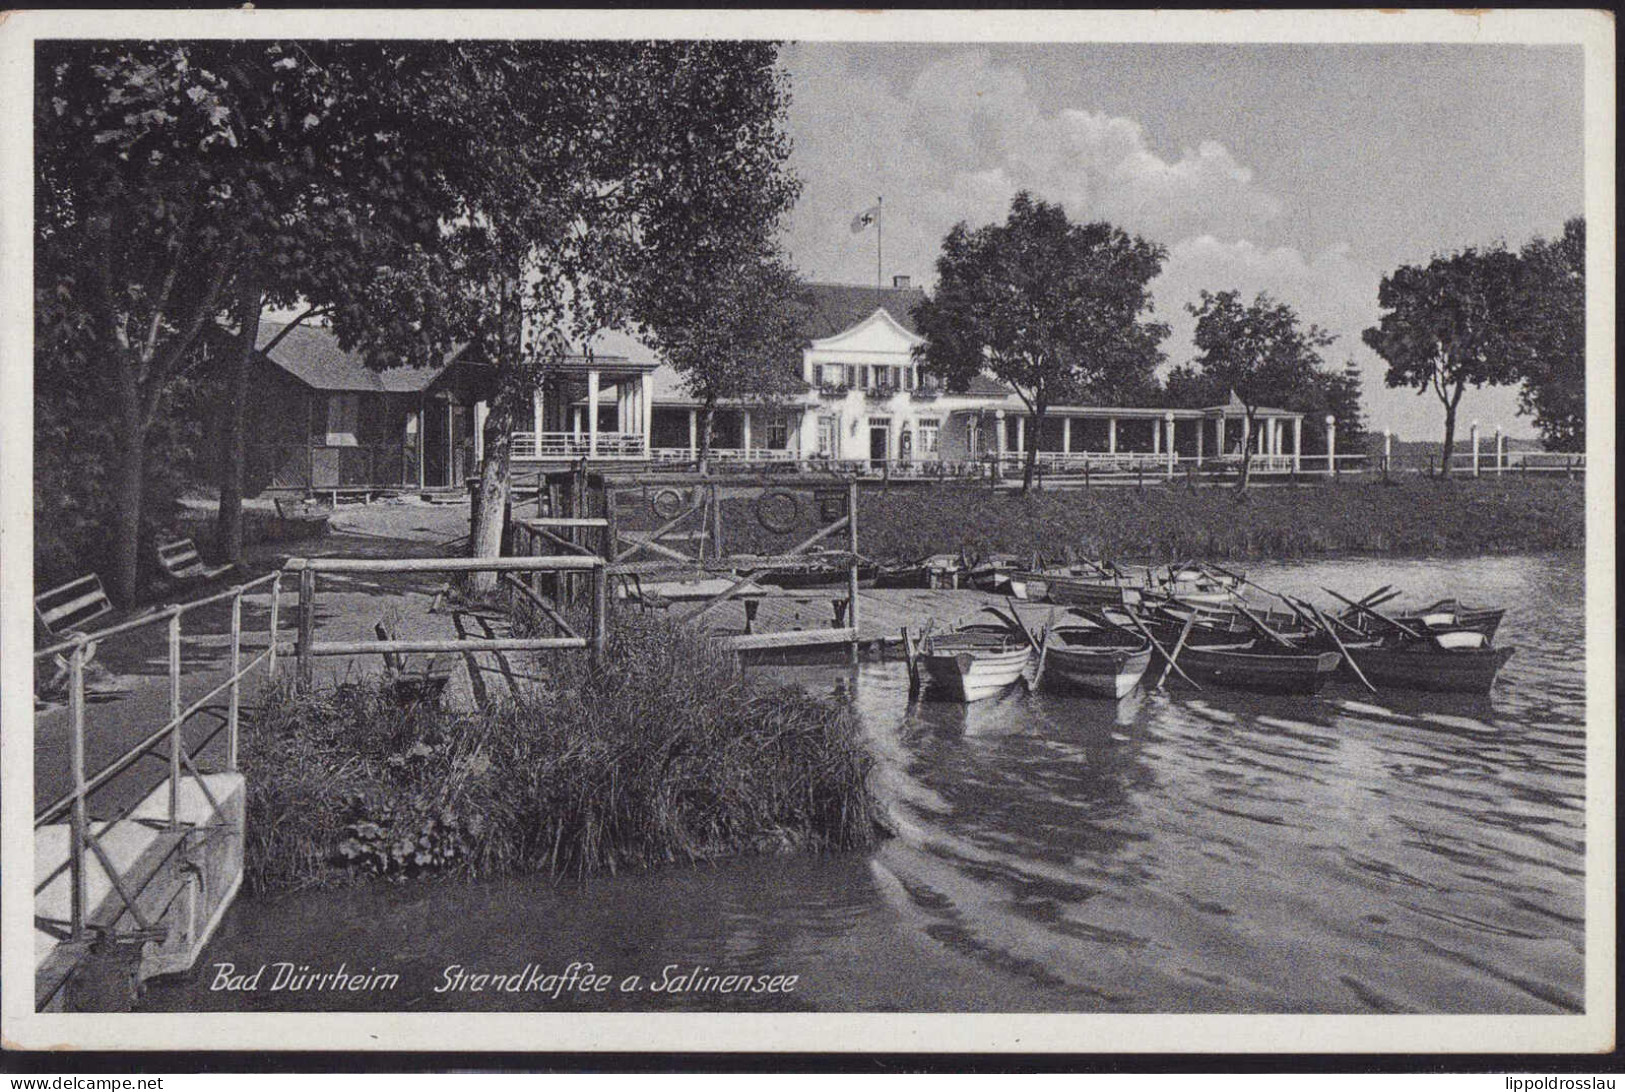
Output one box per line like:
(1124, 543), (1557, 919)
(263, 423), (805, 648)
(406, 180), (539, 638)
(34, 572), (283, 941)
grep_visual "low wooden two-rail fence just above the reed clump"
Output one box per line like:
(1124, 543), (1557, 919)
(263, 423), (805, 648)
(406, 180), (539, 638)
(283, 556), (608, 686)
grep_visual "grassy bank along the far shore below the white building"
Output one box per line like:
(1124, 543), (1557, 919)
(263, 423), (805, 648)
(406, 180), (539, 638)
(726, 478), (1586, 561)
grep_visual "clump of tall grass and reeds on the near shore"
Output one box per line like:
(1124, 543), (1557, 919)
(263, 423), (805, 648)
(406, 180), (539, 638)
(242, 616), (878, 892)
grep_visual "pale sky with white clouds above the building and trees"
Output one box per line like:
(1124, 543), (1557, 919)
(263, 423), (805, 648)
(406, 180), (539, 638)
(782, 42), (1584, 439)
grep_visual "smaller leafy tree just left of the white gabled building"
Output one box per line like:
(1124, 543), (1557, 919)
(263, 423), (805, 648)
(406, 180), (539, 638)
(640, 254), (809, 468)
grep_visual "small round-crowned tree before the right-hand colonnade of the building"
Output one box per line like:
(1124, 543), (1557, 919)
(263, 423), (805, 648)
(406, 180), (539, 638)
(1186, 289), (1336, 494)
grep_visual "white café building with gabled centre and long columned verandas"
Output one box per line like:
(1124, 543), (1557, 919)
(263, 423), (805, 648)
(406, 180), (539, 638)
(514, 278), (1303, 475)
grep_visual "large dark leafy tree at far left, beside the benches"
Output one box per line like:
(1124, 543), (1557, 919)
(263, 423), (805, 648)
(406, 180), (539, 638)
(36, 42), (464, 601)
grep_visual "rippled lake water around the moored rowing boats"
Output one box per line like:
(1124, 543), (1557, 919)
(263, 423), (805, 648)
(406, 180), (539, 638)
(141, 553), (1586, 1012)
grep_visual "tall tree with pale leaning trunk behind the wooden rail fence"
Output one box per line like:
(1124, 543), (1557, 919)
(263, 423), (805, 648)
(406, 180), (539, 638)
(406, 41), (788, 593)
